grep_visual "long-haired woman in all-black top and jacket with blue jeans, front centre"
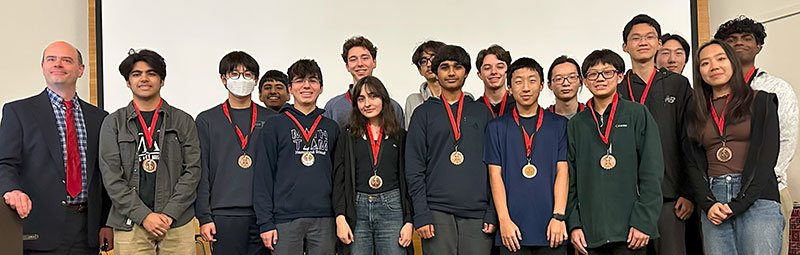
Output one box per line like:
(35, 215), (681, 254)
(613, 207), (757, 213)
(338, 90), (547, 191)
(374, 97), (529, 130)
(333, 76), (413, 255)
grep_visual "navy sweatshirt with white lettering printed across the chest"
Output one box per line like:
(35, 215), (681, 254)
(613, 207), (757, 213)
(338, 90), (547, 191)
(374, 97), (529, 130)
(253, 105), (339, 233)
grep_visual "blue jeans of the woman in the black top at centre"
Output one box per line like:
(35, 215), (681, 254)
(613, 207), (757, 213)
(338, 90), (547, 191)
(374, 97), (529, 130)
(350, 189), (406, 255)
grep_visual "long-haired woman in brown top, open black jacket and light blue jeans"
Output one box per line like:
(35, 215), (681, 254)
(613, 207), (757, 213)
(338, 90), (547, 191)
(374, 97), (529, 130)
(684, 40), (784, 255)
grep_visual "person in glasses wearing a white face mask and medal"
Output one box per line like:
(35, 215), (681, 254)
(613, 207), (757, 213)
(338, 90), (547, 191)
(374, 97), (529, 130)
(195, 51), (275, 254)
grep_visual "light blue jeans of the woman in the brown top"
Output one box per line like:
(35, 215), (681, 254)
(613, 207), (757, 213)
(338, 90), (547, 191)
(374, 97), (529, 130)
(701, 174), (785, 255)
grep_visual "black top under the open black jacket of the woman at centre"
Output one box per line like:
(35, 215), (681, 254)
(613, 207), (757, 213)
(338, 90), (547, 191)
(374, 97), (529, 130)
(354, 134), (400, 194)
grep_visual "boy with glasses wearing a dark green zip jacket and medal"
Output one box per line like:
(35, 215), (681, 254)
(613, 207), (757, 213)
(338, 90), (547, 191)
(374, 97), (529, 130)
(567, 49), (664, 254)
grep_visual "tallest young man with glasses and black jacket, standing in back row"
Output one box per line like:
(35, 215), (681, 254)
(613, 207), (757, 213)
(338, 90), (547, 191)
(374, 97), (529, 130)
(617, 14), (694, 254)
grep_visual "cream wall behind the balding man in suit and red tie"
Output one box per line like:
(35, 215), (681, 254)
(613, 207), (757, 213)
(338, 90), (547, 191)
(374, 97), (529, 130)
(0, 0), (89, 116)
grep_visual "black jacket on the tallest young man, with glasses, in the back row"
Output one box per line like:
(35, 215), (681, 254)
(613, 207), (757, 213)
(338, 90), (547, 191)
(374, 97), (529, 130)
(617, 68), (693, 201)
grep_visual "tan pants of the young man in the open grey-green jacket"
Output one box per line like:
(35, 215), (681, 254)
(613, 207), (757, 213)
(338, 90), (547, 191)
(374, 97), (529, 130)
(114, 221), (197, 255)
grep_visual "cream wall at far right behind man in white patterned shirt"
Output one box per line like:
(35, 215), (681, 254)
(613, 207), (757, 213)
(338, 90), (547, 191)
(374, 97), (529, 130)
(708, 0), (800, 201)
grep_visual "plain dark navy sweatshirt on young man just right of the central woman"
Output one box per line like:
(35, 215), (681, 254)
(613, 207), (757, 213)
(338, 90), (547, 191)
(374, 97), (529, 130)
(406, 96), (497, 228)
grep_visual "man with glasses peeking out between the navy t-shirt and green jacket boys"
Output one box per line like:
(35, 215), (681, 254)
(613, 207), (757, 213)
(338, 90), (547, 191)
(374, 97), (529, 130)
(547, 56), (586, 119)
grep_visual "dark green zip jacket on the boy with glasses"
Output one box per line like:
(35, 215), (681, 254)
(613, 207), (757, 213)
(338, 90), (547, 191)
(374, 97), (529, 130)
(567, 100), (664, 248)
